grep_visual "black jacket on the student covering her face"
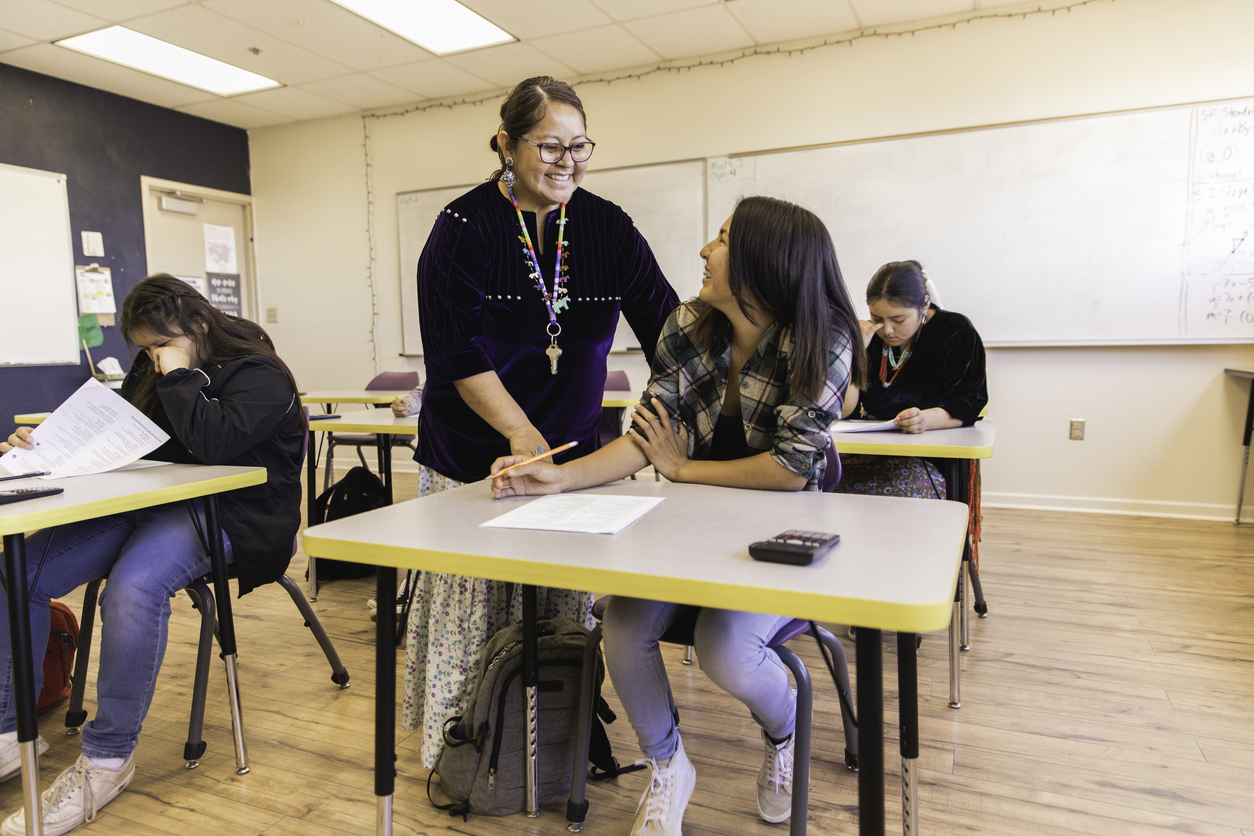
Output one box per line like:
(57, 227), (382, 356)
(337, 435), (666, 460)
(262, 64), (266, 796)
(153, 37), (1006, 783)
(122, 353), (306, 595)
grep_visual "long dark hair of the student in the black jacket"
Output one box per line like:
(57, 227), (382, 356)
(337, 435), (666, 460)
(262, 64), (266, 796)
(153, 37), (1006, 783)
(118, 273), (300, 415)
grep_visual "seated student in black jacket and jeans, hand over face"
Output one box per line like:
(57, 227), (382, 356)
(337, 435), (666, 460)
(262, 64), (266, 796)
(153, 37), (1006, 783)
(0, 273), (306, 836)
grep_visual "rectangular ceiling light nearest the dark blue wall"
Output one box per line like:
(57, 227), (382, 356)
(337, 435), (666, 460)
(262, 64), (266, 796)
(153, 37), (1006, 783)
(55, 26), (282, 95)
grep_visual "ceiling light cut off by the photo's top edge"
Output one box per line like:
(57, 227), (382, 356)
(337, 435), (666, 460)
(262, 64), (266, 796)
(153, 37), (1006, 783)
(331, 0), (517, 55)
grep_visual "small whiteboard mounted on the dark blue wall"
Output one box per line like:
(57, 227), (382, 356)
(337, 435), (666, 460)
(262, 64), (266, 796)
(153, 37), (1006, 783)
(0, 164), (79, 366)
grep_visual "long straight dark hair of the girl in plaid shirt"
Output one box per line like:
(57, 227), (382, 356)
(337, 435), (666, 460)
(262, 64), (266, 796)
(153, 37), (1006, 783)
(693, 196), (867, 397)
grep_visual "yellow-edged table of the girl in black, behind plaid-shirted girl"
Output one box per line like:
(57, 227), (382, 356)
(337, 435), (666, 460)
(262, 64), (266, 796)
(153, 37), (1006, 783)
(831, 419), (997, 708)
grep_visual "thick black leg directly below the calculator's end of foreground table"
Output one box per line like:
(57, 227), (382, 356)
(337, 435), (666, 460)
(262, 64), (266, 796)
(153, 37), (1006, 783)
(856, 627), (884, 836)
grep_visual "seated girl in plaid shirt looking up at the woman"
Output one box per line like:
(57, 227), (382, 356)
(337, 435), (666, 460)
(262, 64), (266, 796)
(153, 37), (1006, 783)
(492, 197), (867, 836)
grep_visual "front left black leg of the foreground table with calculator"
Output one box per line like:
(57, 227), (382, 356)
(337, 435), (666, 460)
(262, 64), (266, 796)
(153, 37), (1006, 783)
(375, 567), (396, 836)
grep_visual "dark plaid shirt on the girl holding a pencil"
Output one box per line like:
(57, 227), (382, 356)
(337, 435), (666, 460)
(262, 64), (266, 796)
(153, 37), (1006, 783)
(641, 302), (853, 491)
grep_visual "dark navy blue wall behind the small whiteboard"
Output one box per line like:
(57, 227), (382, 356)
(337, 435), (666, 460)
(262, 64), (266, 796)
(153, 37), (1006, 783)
(0, 64), (251, 439)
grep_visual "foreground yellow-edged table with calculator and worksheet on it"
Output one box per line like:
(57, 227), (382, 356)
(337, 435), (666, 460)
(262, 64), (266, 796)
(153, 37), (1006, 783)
(305, 480), (967, 836)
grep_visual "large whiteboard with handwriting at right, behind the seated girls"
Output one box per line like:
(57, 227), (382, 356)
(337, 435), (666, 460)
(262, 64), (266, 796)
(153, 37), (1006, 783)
(706, 102), (1254, 345)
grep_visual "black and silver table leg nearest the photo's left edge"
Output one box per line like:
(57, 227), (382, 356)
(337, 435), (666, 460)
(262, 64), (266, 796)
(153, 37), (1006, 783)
(4, 534), (44, 836)
